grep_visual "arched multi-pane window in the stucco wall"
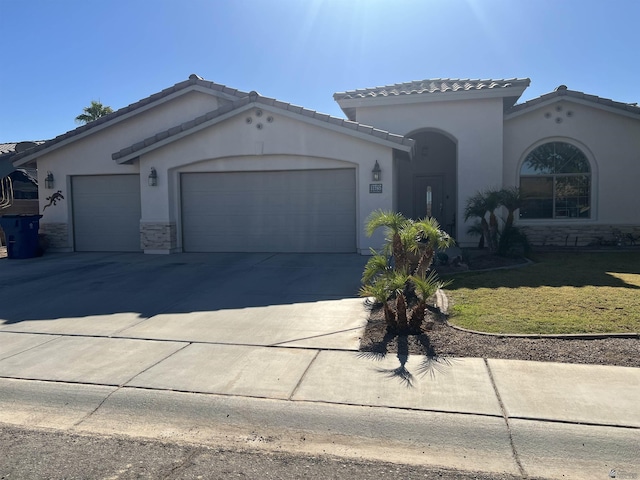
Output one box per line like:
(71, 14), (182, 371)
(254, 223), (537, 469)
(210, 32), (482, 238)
(520, 142), (591, 219)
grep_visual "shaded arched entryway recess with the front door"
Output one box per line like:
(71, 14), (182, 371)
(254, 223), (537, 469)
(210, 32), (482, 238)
(398, 130), (457, 236)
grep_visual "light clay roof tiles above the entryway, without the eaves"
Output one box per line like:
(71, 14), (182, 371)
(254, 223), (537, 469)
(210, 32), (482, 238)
(333, 78), (530, 101)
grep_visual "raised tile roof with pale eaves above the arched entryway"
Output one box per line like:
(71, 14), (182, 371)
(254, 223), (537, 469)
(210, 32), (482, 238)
(333, 78), (530, 120)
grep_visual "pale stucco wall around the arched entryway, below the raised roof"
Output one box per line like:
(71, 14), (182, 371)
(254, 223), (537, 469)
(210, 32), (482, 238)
(356, 98), (503, 246)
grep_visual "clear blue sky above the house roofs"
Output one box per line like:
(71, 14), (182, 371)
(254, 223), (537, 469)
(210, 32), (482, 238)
(0, 0), (640, 143)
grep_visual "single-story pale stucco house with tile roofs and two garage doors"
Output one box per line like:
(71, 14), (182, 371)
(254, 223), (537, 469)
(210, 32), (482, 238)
(12, 75), (640, 254)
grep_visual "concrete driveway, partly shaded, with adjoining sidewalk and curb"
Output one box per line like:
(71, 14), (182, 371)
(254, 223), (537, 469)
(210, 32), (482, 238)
(0, 253), (640, 479)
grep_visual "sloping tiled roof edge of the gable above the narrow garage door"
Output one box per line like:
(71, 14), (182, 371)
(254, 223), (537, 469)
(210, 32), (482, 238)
(12, 74), (248, 167)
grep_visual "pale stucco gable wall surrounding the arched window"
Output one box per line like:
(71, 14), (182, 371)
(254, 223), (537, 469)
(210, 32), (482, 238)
(504, 99), (640, 225)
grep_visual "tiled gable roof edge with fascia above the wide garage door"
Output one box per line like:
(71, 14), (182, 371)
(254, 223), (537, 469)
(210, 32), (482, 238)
(112, 92), (414, 163)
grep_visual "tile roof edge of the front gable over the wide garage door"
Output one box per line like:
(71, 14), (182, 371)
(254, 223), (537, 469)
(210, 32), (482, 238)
(111, 92), (415, 161)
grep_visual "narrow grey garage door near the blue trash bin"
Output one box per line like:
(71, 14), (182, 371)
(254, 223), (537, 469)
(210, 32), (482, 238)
(71, 175), (141, 252)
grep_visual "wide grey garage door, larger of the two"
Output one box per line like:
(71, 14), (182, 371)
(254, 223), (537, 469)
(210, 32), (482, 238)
(181, 169), (356, 252)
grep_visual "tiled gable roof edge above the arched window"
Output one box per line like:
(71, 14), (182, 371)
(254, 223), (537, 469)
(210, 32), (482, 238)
(505, 85), (640, 120)
